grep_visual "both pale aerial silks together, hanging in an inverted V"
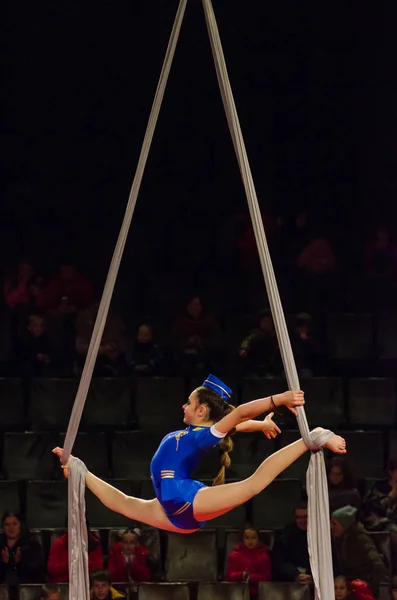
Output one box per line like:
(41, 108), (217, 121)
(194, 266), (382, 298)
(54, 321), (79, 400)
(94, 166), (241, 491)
(62, 0), (334, 600)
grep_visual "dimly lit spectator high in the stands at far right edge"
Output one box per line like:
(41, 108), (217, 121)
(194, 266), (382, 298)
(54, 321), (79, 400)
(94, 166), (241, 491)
(365, 227), (397, 276)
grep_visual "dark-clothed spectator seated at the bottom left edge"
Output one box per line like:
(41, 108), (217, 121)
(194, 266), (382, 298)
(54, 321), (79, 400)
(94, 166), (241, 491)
(0, 512), (44, 587)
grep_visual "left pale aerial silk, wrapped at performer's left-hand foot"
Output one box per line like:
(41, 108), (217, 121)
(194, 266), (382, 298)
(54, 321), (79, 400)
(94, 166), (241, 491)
(62, 0), (187, 600)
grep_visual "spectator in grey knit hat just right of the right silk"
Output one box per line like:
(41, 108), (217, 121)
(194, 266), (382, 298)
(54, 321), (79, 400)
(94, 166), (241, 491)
(331, 506), (388, 596)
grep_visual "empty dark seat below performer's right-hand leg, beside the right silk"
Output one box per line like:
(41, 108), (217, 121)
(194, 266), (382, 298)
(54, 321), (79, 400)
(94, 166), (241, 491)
(252, 479), (302, 529)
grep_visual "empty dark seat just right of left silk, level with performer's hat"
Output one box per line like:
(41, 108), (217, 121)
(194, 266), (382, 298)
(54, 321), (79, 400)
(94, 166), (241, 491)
(83, 378), (133, 428)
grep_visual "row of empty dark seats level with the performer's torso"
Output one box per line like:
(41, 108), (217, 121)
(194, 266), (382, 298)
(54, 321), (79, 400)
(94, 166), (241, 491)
(0, 428), (397, 481)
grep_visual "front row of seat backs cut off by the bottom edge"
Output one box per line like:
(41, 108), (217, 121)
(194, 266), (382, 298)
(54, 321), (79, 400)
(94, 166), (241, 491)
(0, 582), (312, 600)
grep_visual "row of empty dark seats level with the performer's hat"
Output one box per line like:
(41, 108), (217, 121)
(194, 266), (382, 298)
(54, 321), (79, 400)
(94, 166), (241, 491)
(0, 377), (397, 432)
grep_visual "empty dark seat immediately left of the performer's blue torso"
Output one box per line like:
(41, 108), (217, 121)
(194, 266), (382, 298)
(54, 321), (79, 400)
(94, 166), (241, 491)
(111, 431), (162, 479)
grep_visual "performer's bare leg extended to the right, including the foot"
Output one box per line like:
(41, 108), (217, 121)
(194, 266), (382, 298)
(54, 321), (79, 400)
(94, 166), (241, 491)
(193, 435), (346, 521)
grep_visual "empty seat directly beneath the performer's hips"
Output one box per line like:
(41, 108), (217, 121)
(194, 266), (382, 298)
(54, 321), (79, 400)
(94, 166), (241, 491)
(166, 529), (218, 581)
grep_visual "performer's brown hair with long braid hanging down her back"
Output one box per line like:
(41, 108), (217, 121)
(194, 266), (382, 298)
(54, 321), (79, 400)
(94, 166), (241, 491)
(196, 386), (236, 485)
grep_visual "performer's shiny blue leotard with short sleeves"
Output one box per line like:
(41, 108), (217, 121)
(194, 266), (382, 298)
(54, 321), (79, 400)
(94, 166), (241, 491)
(150, 425), (225, 529)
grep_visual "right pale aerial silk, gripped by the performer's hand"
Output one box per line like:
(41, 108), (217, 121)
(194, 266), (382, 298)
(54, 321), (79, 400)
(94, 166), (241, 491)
(202, 0), (334, 600)
